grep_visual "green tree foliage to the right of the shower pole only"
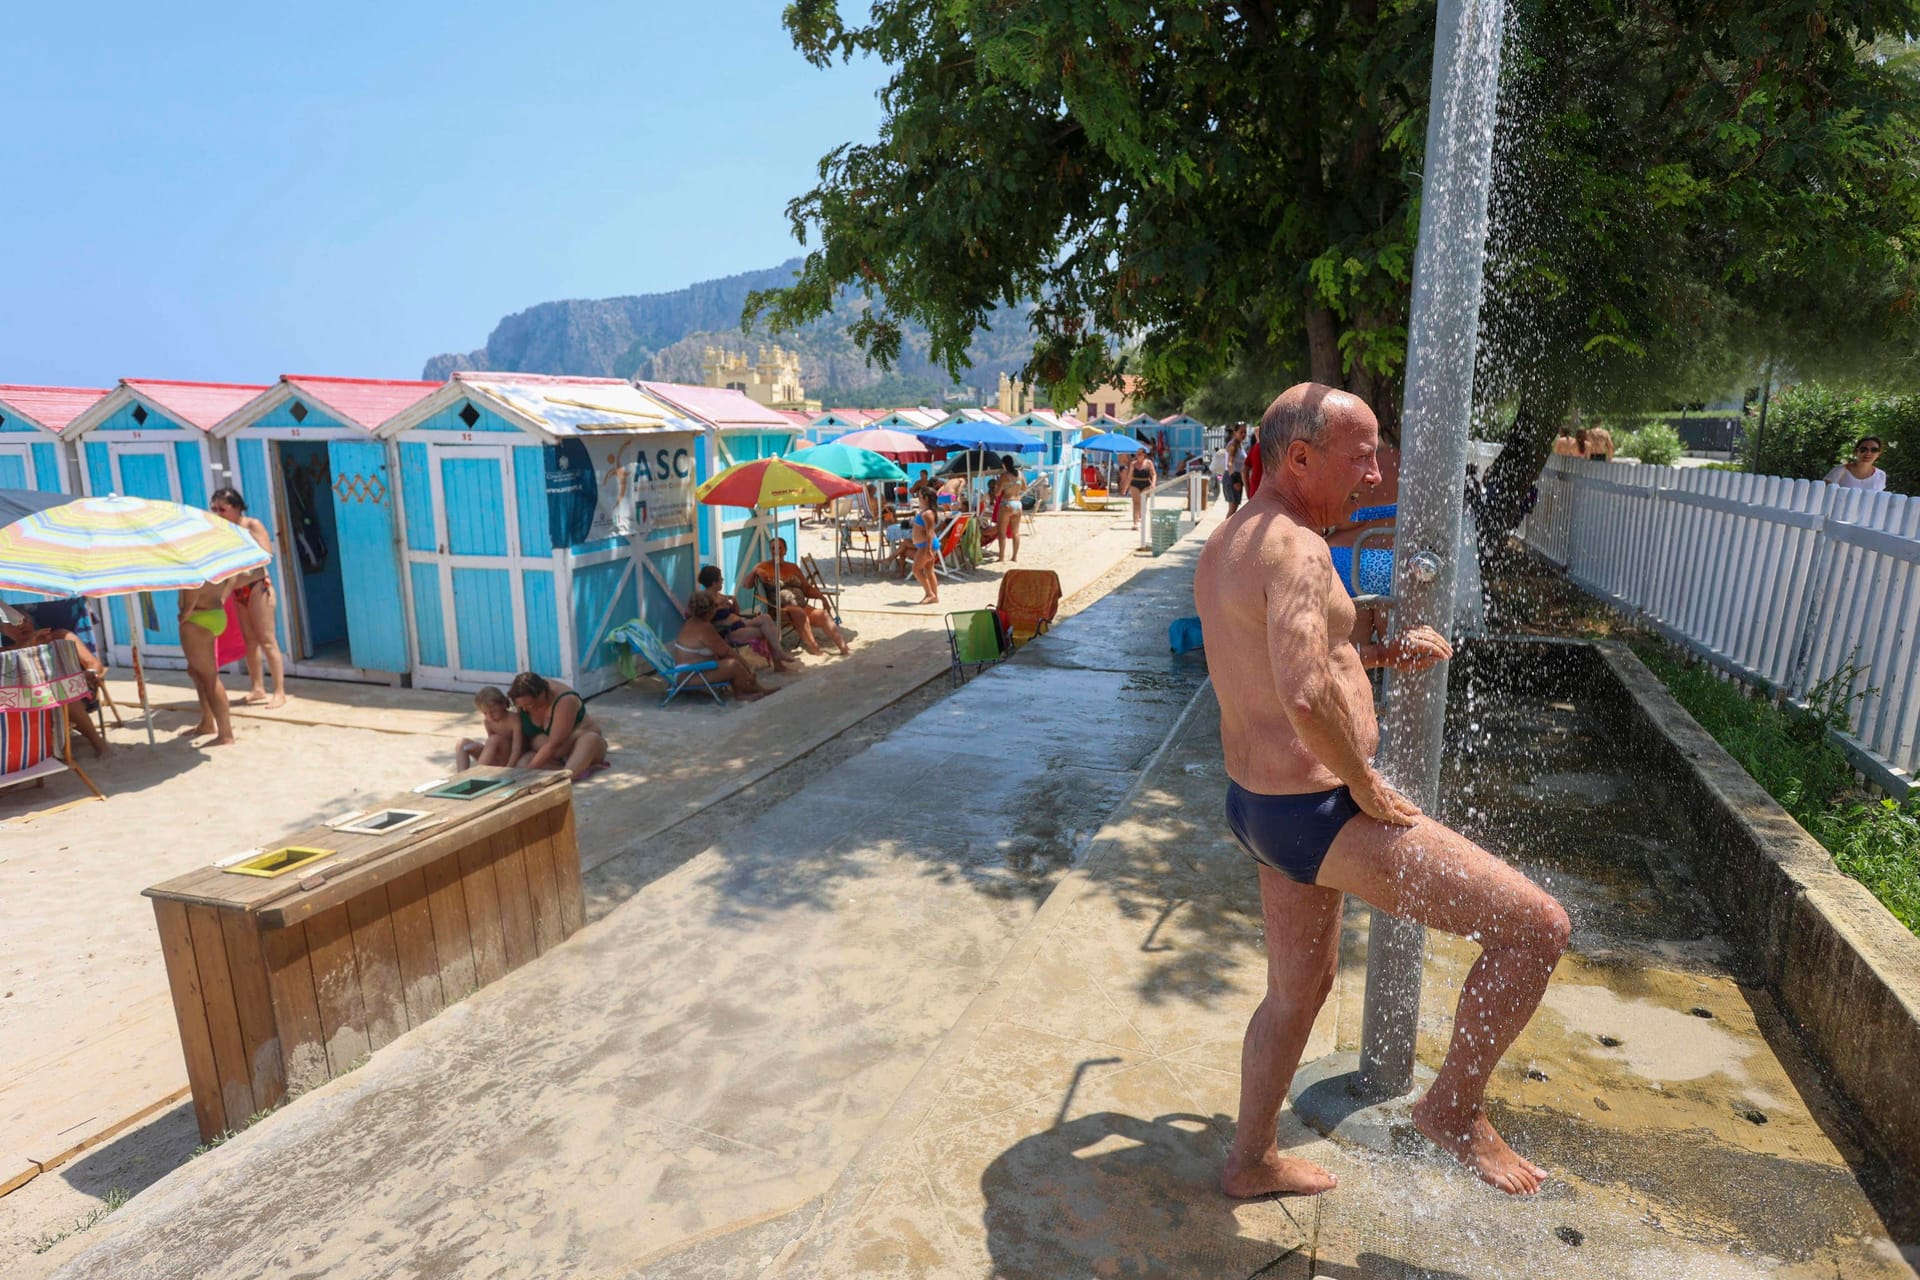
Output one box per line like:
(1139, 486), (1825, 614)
(1480, 0), (1920, 528)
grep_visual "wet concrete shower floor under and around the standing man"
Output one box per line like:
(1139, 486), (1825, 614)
(760, 652), (1920, 1280)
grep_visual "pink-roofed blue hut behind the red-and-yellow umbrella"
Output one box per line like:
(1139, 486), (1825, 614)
(639, 382), (804, 594)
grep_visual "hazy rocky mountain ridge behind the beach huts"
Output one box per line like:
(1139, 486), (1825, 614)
(420, 257), (1033, 403)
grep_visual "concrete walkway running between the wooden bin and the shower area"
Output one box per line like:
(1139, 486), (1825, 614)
(37, 525), (1204, 1278)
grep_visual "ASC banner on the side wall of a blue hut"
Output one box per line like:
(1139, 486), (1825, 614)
(545, 434), (695, 547)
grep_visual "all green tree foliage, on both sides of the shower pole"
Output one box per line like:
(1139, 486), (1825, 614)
(749, 0), (1920, 498)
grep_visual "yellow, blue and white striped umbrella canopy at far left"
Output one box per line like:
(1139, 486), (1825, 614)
(0, 497), (271, 597)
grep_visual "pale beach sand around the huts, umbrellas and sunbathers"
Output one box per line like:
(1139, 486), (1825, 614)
(0, 491), (1177, 1228)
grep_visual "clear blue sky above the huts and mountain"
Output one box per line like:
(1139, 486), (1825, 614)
(0, 0), (885, 386)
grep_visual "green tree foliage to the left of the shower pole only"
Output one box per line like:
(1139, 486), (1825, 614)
(749, 0), (1434, 428)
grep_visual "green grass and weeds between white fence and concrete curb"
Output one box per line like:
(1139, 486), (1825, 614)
(1634, 643), (1920, 935)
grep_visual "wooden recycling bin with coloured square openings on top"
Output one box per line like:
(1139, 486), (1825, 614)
(146, 768), (584, 1140)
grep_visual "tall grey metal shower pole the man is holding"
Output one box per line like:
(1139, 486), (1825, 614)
(1359, 0), (1505, 1098)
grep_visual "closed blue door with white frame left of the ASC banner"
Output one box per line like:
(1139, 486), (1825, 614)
(407, 443), (526, 687)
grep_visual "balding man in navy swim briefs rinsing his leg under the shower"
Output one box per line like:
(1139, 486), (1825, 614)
(1194, 384), (1569, 1196)
